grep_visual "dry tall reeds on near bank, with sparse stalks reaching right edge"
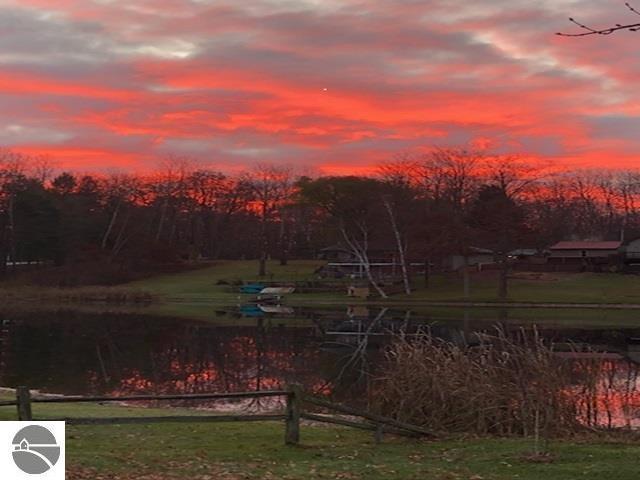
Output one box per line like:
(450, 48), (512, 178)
(374, 330), (640, 439)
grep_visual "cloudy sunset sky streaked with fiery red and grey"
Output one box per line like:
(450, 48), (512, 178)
(0, 0), (640, 174)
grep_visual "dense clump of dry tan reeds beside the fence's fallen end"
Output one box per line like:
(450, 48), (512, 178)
(374, 330), (584, 438)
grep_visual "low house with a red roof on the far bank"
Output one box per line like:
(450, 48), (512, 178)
(549, 240), (622, 265)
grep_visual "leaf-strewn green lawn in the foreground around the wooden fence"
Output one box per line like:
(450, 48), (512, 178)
(0, 404), (640, 480)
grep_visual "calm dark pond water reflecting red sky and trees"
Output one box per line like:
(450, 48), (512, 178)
(0, 306), (640, 422)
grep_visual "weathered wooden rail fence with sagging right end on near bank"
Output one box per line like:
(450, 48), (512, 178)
(0, 385), (435, 445)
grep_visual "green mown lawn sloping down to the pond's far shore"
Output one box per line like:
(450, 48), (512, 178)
(126, 260), (640, 305)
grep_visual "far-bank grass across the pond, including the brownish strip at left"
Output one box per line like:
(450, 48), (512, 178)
(7, 260), (640, 308)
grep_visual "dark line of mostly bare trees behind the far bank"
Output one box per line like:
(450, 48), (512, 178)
(0, 148), (640, 288)
